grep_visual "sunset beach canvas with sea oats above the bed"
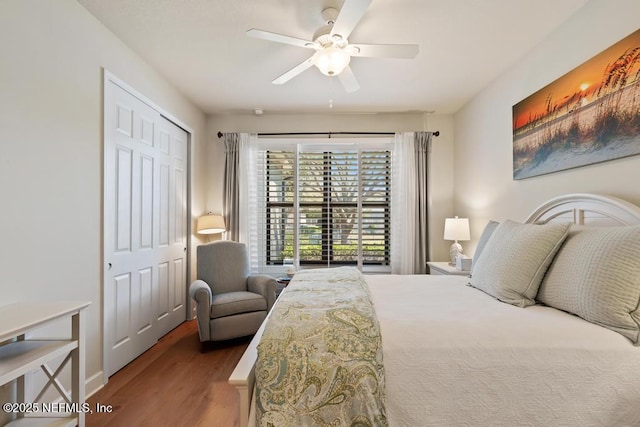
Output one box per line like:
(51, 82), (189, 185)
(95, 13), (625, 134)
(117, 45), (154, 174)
(513, 30), (640, 180)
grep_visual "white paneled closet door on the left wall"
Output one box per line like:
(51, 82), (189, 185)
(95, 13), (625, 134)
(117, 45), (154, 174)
(104, 80), (188, 376)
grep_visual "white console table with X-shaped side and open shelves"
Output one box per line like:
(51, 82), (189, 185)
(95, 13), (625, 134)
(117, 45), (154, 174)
(0, 301), (90, 426)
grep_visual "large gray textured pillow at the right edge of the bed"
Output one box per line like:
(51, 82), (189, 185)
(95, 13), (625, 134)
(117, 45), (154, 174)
(537, 226), (640, 345)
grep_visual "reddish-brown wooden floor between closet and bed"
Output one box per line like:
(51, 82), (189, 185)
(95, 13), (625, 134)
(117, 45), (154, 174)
(86, 321), (249, 427)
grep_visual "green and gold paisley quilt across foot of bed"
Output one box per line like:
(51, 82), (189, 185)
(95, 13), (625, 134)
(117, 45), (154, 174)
(256, 267), (388, 427)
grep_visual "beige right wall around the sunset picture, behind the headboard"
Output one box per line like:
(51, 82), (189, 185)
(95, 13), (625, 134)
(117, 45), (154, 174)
(454, 0), (640, 254)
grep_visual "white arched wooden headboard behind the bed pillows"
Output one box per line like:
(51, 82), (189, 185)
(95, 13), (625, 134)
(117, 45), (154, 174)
(525, 193), (640, 227)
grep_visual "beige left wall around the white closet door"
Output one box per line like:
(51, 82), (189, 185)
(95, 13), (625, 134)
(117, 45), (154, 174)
(0, 0), (206, 400)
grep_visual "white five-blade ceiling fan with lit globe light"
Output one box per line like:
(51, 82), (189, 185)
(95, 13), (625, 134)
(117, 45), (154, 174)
(247, 0), (418, 92)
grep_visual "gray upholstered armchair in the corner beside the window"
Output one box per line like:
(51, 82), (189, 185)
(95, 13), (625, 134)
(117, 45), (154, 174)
(189, 241), (276, 343)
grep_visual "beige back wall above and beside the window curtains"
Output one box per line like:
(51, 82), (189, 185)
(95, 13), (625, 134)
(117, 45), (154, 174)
(207, 112), (454, 259)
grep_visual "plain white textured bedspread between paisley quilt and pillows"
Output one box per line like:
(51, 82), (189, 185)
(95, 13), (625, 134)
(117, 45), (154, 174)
(366, 275), (640, 427)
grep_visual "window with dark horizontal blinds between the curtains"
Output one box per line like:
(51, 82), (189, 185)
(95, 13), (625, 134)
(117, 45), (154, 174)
(258, 139), (391, 266)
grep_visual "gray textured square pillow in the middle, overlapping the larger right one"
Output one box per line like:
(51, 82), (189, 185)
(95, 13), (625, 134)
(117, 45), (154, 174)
(471, 220), (569, 307)
